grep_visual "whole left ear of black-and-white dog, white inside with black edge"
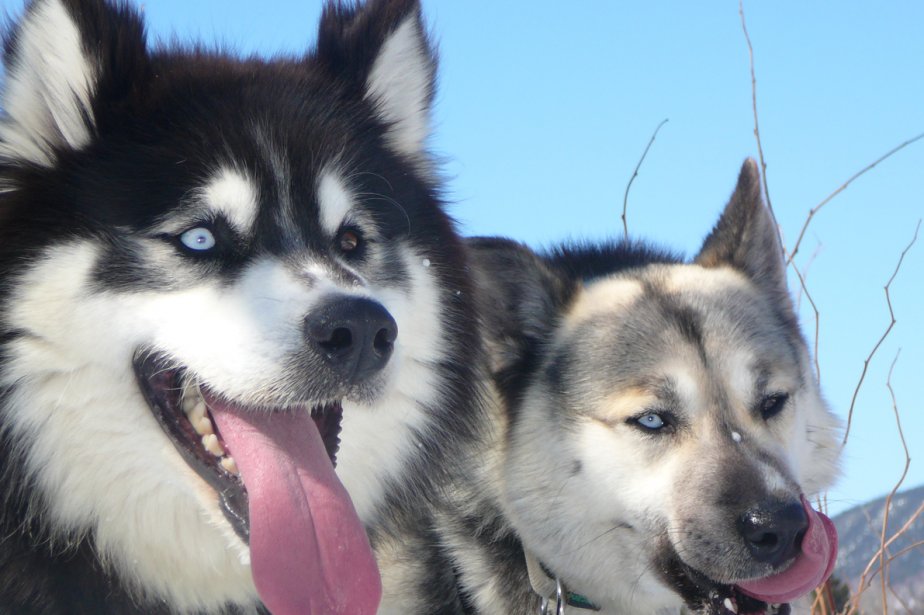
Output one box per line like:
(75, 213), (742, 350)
(0, 0), (146, 166)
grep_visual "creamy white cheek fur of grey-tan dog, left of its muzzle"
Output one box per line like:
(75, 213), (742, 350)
(505, 383), (680, 612)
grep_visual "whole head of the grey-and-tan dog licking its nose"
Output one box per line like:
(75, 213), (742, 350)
(477, 161), (839, 613)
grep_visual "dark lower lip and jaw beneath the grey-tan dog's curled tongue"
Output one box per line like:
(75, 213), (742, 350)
(658, 549), (791, 615)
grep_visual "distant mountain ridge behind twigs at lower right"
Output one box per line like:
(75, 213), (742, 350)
(833, 485), (924, 614)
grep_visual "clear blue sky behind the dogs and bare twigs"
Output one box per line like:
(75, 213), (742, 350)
(0, 0), (924, 512)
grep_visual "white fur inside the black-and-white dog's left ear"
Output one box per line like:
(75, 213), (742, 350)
(0, 0), (98, 166)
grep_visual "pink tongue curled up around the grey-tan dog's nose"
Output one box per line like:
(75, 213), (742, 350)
(738, 496), (837, 604)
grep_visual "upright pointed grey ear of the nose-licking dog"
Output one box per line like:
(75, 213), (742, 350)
(694, 158), (788, 297)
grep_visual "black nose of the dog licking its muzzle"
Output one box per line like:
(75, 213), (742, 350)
(738, 500), (809, 566)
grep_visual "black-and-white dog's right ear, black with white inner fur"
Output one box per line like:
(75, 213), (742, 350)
(317, 0), (436, 161)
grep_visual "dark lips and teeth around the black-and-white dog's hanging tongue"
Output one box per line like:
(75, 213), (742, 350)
(133, 352), (344, 543)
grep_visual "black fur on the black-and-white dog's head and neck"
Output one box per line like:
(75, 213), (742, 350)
(0, 0), (483, 615)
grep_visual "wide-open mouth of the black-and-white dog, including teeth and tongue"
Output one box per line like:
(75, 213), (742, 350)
(133, 353), (380, 613)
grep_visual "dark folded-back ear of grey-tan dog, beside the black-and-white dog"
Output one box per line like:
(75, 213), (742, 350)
(466, 237), (574, 389)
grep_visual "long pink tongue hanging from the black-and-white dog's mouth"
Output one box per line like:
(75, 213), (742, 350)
(211, 404), (381, 615)
